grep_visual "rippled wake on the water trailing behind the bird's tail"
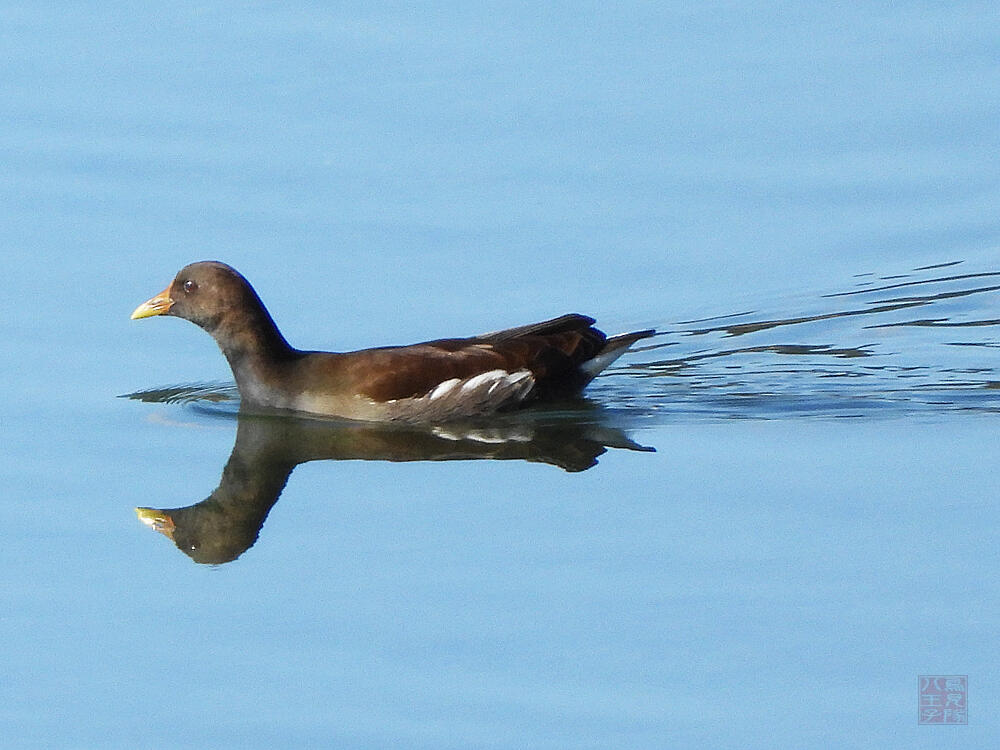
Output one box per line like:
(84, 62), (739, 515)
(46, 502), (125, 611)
(604, 261), (1000, 419)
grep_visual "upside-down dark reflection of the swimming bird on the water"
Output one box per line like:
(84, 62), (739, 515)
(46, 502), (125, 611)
(136, 414), (654, 564)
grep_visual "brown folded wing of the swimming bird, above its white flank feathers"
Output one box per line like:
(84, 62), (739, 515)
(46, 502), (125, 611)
(343, 315), (606, 401)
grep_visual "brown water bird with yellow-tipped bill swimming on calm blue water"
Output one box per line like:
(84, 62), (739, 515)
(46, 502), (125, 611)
(131, 261), (656, 423)
